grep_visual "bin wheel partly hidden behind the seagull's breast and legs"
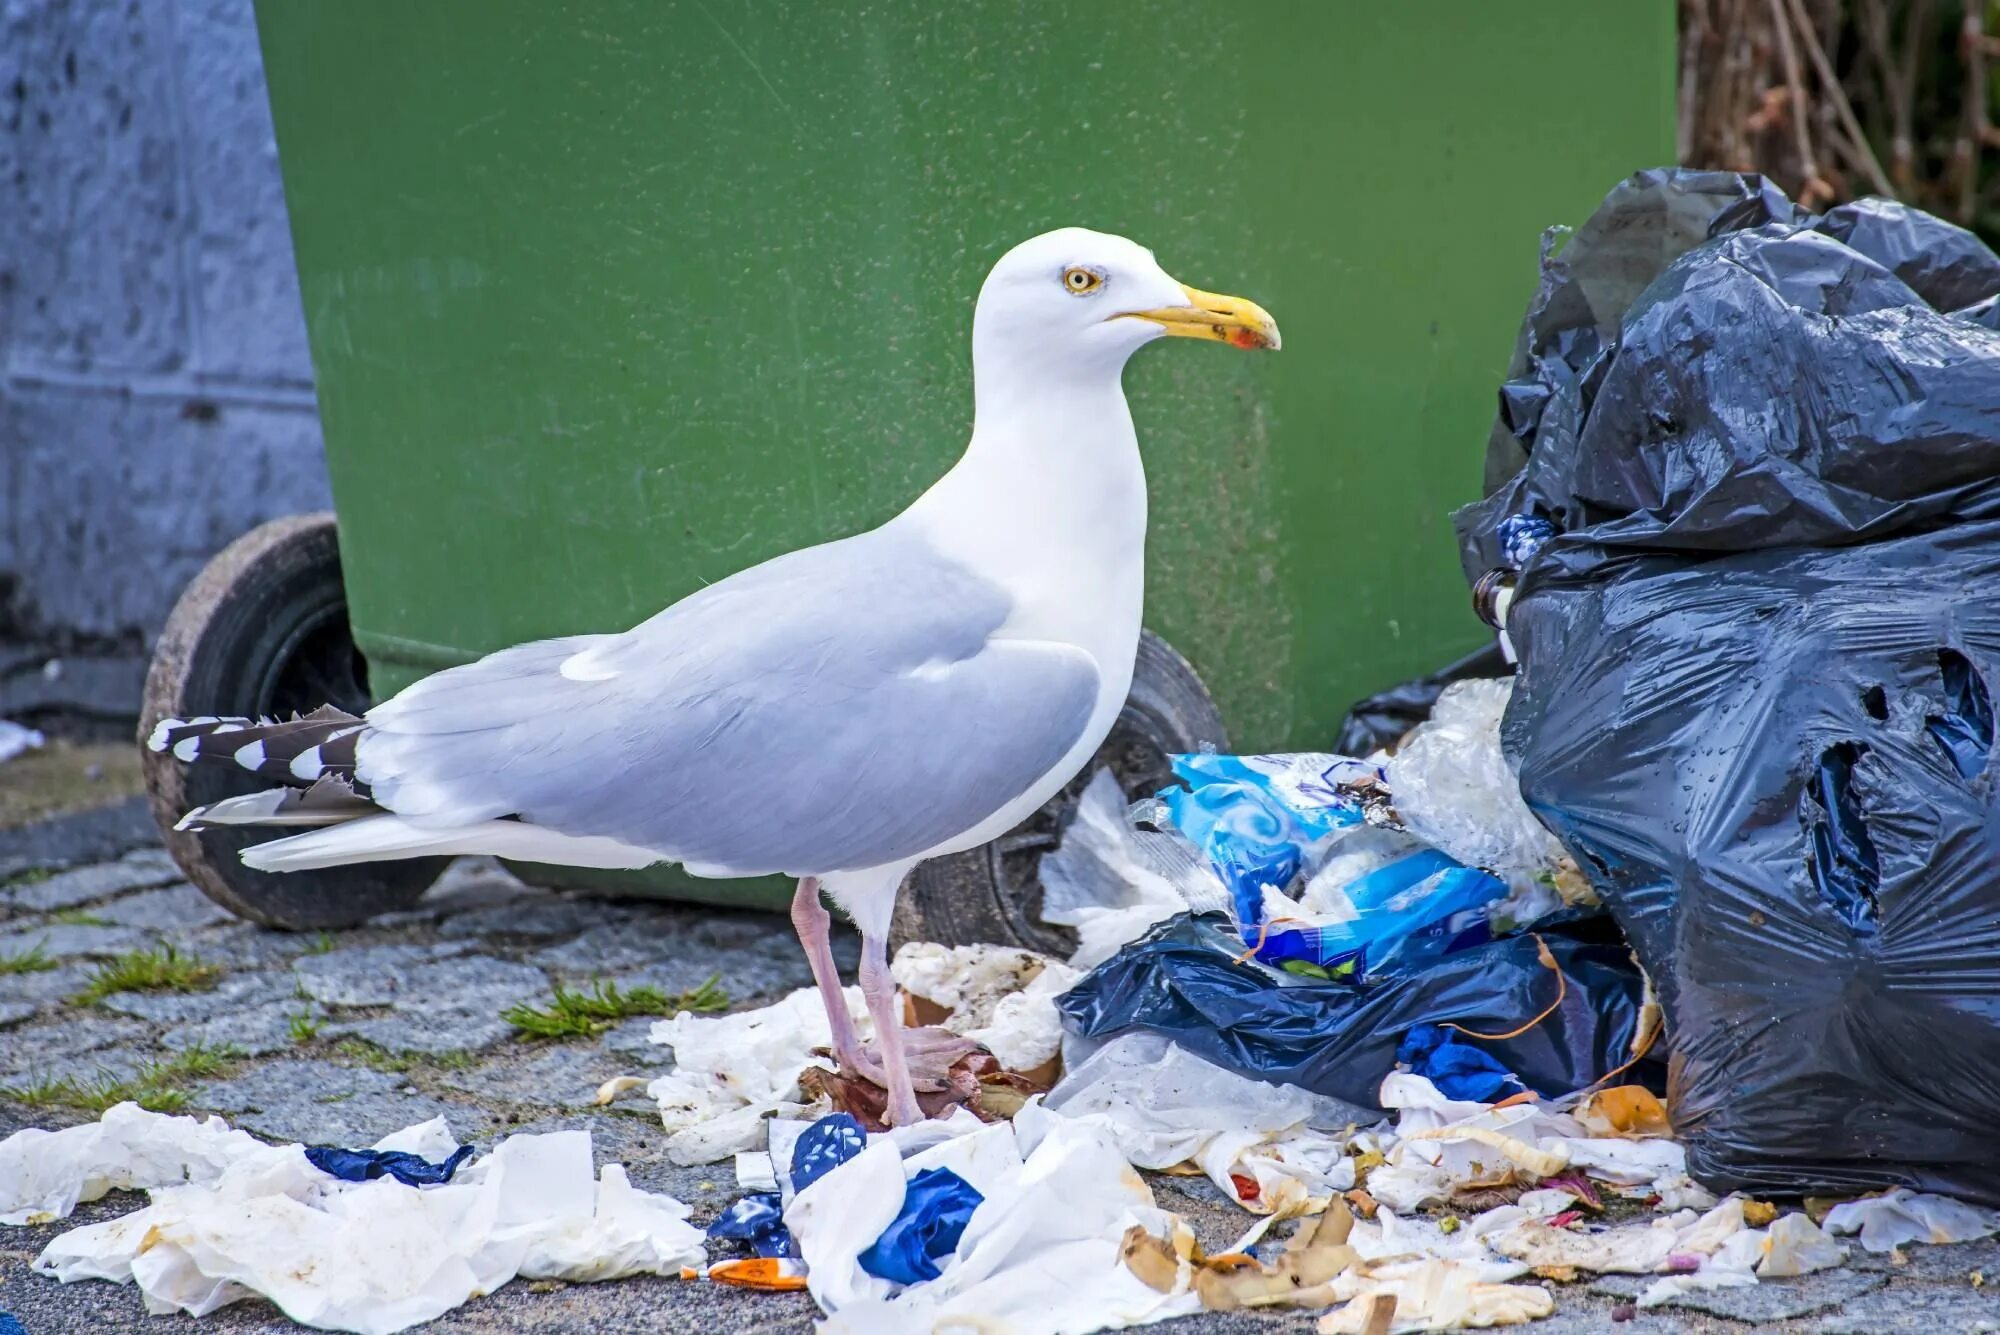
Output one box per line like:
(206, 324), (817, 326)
(890, 632), (1228, 957)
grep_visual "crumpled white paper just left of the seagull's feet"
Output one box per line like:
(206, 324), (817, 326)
(646, 987), (874, 1165)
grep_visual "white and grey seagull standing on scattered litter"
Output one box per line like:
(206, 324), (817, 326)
(148, 228), (1278, 1125)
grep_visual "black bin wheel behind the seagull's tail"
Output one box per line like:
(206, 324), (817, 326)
(140, 514), (450, 931)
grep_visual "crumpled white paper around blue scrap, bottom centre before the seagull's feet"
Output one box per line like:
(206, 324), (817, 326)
(786, 1103), (1200, 1335)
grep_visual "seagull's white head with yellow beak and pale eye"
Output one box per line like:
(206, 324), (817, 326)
(972, 228), (1278, 372)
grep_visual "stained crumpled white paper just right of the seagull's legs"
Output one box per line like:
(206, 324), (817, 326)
(888, 941), (1082, 1071)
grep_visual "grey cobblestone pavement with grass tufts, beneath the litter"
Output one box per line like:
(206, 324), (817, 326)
(0, 803), (2000, 1335)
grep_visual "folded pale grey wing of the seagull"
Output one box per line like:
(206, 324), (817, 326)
(360, 530), (1100, 875)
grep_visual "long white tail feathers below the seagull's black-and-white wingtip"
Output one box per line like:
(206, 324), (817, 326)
(242, 813), (666, 871)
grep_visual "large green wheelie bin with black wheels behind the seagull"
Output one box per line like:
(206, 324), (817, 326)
(133, 0), (1674, 945)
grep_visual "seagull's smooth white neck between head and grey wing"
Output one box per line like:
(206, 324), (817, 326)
(896, 351), (1146, 647)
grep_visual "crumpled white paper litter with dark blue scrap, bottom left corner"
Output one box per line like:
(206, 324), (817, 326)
(0, 1103), (704, 1335)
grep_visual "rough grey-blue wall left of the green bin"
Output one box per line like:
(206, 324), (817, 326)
(0, 0), (328, 717)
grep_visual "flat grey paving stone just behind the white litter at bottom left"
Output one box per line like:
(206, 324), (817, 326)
(194, 1059), (472, 1147)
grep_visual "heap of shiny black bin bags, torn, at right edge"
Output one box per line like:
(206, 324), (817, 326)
(1456, 163), (2000, 1203)
